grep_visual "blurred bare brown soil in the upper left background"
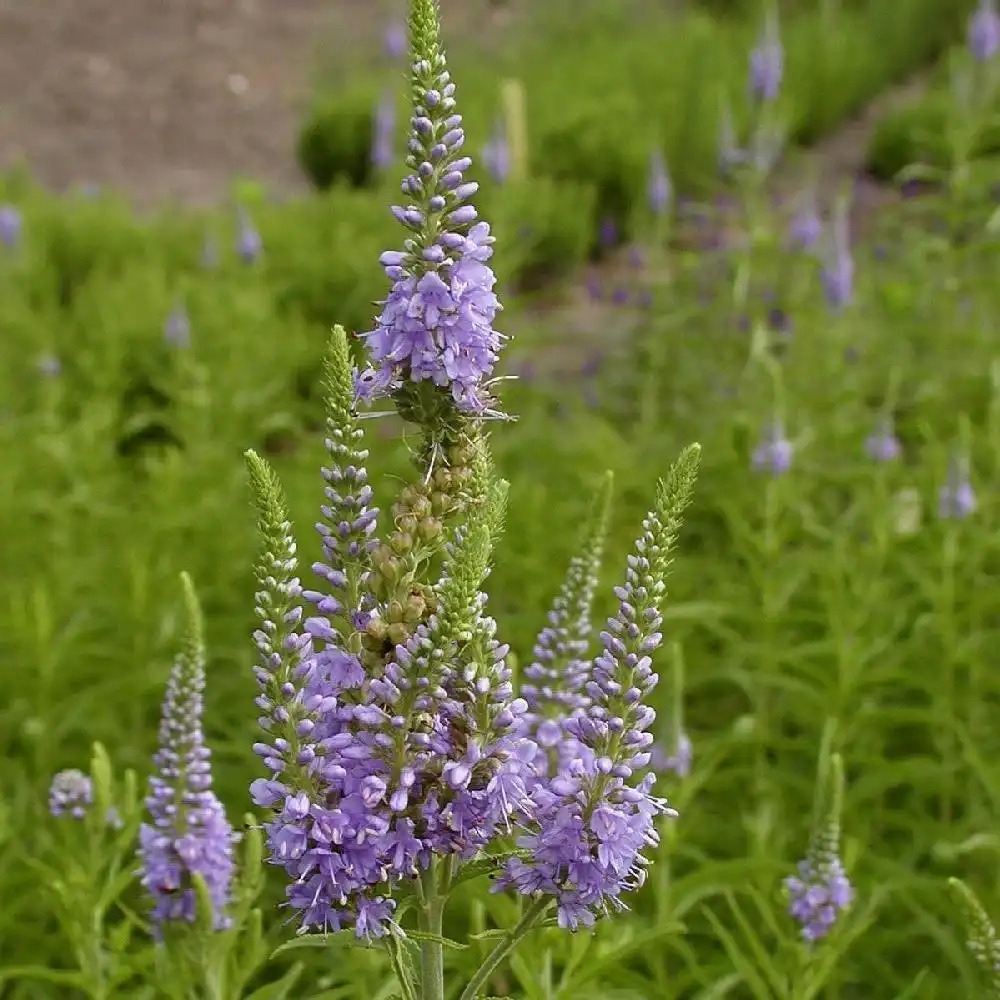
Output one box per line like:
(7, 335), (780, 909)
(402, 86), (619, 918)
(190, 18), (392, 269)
(0, 0), (520, 205)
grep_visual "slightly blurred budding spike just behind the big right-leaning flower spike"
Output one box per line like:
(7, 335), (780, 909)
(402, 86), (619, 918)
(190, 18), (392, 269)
(521, 472), (614, 747)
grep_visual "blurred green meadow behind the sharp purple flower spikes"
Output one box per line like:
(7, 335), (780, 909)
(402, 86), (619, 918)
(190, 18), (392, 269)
(0, 0), (1000, 1000)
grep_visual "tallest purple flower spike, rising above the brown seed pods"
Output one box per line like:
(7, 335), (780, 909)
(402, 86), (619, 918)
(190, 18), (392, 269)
(358, 0), (505, 418)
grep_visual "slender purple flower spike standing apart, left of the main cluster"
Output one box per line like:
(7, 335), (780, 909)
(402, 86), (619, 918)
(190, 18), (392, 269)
(139, 574), (236, 931)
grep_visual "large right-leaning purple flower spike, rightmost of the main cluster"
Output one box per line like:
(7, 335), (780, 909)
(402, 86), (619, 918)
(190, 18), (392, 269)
(497, 445), (700, 929)
